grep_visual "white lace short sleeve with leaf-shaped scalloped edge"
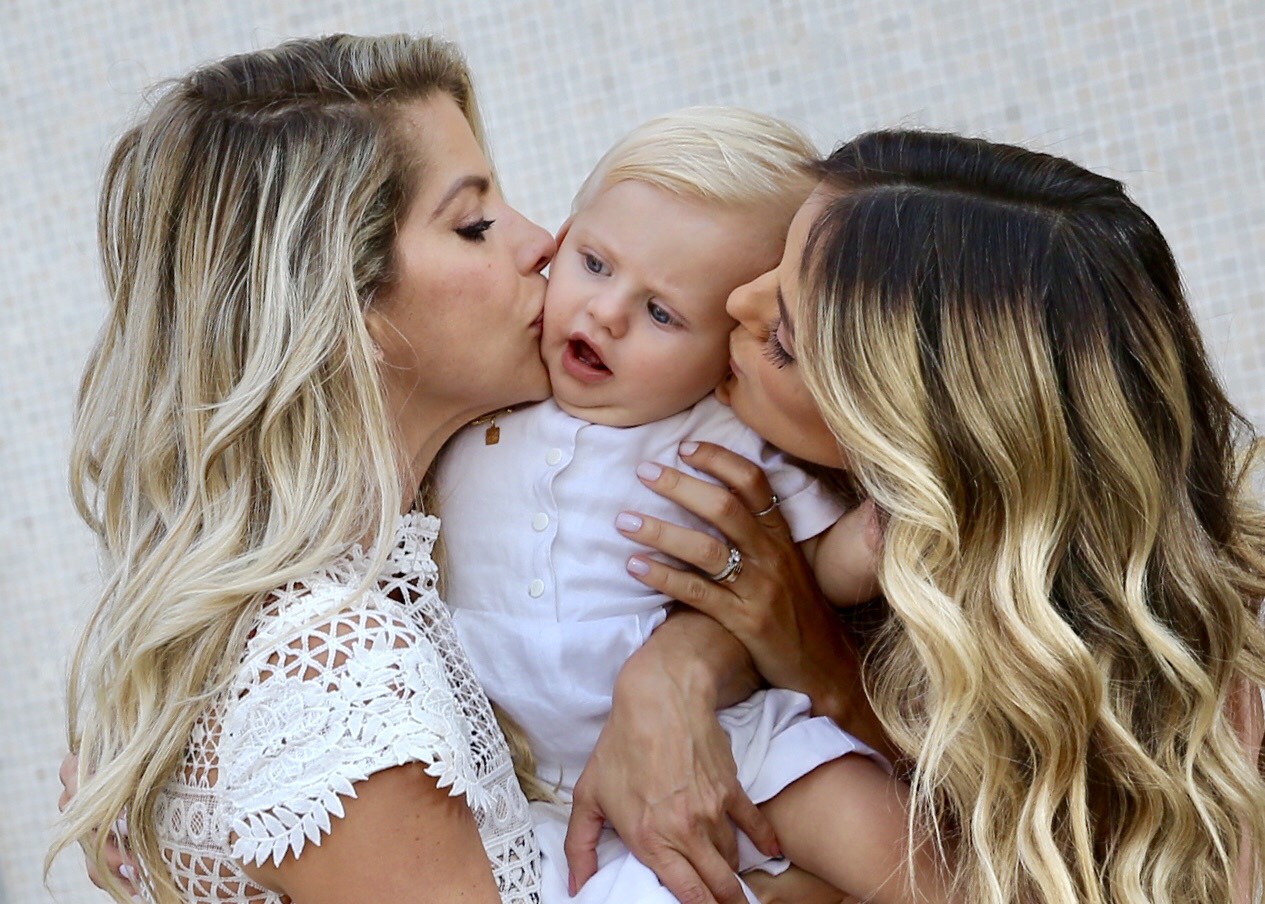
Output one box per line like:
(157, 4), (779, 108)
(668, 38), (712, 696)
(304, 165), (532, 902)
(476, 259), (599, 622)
(219, 601), (488, 865)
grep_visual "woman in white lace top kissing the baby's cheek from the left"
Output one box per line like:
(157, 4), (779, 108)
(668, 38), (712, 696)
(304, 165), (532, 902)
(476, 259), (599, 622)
(54, 35), (554, 904)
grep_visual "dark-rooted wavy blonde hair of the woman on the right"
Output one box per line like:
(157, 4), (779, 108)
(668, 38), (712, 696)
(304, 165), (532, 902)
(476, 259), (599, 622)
(796, 131), (1265, 904)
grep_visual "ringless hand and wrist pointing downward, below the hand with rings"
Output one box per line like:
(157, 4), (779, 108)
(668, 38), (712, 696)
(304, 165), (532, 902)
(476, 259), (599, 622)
(576, 609), (778, 904)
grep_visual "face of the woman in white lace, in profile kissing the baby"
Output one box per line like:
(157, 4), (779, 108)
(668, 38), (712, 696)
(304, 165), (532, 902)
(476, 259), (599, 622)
(367, 94), (554, 435)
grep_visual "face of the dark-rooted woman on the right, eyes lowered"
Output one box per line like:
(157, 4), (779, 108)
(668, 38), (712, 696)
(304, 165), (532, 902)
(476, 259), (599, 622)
(716, 192), (845, 468)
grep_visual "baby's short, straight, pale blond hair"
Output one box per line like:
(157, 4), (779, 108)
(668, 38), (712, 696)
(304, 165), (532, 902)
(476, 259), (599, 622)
(572, 106), (817, 221)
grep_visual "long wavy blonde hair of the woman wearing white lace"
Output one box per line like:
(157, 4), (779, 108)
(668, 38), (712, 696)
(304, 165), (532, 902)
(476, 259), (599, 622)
(46, 35), (526, 901)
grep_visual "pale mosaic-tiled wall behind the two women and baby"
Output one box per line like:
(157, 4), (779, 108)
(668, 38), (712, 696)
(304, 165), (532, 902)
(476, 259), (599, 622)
(0, 0), (1265, 904)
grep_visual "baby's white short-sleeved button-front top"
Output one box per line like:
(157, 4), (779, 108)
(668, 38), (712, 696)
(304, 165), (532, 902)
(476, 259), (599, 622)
(436, 397), (841, 791)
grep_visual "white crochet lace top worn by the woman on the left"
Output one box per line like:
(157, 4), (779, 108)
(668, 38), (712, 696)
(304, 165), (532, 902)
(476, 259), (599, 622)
(144, 513), (539, 904)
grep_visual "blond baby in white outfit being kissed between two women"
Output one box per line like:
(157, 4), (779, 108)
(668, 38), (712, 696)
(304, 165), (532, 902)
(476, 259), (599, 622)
(438, 107), (895, 900)
